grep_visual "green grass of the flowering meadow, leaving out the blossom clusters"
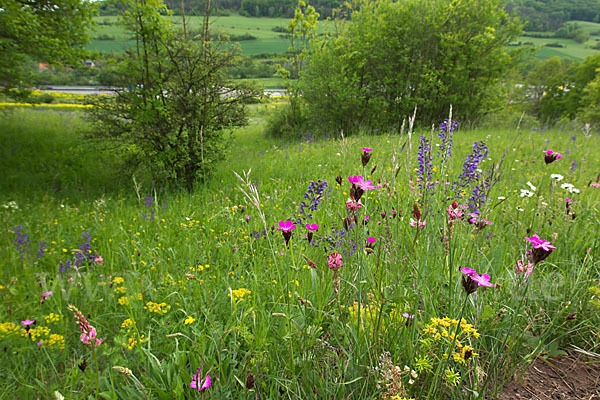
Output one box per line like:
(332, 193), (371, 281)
(0, 104), (600, 399)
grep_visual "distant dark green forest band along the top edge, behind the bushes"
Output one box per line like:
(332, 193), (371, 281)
(100, 0), (600, 28)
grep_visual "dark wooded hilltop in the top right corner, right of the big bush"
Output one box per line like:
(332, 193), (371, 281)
(507, 0), (600, 32)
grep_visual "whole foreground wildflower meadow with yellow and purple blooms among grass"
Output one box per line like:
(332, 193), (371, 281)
(0, 108), (600, 399)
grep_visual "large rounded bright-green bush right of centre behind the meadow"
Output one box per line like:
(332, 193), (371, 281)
(301, 0), (520, 132)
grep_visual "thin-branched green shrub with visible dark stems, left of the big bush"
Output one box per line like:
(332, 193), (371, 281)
(90, 0), (258, 189)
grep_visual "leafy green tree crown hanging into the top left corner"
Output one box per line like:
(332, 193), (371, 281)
(0, 0), (95, 86)
